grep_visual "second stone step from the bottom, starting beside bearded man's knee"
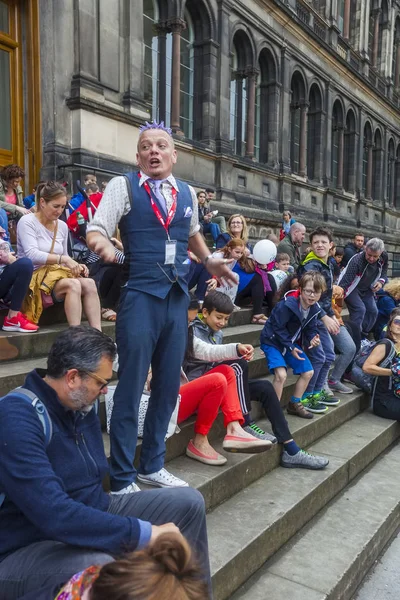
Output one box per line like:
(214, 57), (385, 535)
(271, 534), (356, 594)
(207, 413), (400, 600)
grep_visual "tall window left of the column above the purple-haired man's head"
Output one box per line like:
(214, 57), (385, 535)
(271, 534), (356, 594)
(143, 0), (159, 119)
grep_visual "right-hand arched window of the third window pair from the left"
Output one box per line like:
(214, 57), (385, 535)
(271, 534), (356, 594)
(307, 84), (322, 181)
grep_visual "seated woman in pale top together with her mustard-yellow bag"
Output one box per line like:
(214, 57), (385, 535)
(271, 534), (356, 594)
(17, 181), (101, 329)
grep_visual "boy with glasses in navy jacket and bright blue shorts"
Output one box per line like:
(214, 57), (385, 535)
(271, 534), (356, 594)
(261, 271), (327, 419)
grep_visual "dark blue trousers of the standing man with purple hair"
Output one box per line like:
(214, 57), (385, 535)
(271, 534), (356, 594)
(110, 284), (189, 491)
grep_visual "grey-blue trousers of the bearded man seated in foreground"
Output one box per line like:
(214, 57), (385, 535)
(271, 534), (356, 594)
(0, 488), (211, 600)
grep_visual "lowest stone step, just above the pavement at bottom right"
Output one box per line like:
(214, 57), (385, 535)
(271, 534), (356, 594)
(232, 423), (400, 600)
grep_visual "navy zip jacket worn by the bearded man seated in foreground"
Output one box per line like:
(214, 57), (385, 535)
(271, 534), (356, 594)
(0, 370), (151, 560)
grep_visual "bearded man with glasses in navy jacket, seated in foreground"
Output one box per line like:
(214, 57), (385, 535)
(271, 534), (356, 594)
(0, 326), (210, 600)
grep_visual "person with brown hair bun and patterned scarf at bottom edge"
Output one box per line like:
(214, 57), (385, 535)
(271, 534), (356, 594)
(55, 533), (210, 600)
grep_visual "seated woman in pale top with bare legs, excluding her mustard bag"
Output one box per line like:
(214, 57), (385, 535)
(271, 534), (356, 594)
(17, 181), (101, 329)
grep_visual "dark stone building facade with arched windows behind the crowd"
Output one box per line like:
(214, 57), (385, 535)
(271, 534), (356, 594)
(0, 0), (400, 266)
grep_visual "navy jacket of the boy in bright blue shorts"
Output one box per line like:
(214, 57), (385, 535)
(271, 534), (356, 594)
(260, 291), (326, 355)
